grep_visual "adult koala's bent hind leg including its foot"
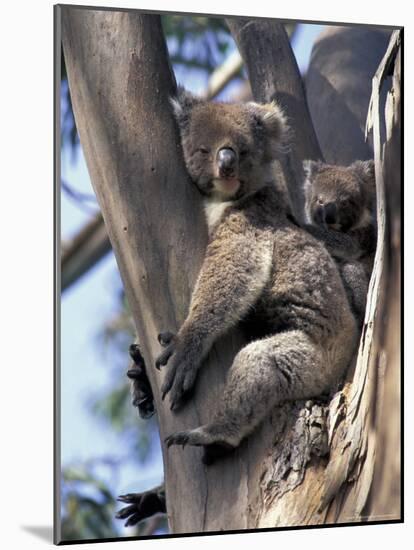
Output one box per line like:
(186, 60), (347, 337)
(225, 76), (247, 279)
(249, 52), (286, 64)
(166, 330), (332, 463)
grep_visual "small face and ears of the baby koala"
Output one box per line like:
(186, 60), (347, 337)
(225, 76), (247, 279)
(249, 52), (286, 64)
(304, 161), (375, 232)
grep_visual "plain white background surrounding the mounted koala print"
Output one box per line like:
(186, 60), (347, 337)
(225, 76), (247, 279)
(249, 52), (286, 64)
(0, 0), (408, 550)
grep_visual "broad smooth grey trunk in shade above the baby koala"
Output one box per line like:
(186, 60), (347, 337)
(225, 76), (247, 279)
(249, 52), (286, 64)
(305, 26), (391, 166)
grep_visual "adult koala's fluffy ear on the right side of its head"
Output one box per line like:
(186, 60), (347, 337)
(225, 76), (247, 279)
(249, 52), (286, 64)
(247, 101), (289, 156)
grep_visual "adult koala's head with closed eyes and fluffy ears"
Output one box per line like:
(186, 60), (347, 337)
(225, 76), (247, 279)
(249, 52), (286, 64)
(172, 89), (285, 200)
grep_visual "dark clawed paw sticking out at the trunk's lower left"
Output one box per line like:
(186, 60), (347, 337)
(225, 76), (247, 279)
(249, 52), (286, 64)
(115, 487), (166, 527)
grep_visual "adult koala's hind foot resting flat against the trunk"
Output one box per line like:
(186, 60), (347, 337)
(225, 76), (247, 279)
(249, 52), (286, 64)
(165, 426), (236, 465)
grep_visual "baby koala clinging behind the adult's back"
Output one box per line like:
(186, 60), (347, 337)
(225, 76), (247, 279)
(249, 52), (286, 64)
(303, 160), (377, 324)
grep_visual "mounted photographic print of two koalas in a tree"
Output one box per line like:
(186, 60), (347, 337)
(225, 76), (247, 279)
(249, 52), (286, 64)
(55, 5), (403, 544)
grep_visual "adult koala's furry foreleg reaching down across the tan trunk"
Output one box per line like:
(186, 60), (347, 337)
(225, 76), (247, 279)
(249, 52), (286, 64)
(157, 226), (273, 409)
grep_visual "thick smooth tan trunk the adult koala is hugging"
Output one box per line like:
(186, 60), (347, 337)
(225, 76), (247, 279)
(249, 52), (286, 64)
(60, 7), (402, 533)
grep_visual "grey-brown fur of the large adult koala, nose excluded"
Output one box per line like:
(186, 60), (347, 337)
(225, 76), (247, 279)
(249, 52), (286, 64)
(157, 91), (356, 462)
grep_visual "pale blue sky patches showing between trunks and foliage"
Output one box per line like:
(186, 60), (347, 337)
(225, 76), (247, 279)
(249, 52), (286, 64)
(61, 21), (323, 533)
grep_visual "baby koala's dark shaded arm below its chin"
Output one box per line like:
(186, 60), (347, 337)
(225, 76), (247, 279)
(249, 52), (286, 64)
(304, 224), (376, 260)
